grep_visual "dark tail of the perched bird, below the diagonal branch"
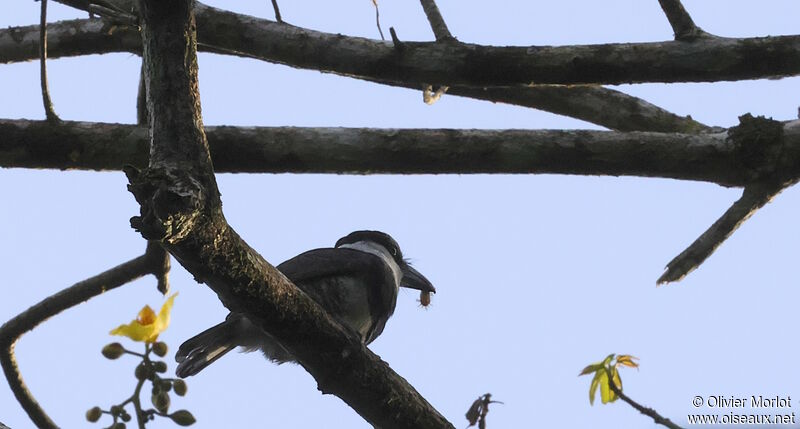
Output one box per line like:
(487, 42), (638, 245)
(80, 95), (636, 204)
(175, 318), (239, 378)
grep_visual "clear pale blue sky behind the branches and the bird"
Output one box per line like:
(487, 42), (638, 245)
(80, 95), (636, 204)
(0, 0), (800, 429)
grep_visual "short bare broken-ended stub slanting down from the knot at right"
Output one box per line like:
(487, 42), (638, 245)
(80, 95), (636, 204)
(657, 184), (784, 284)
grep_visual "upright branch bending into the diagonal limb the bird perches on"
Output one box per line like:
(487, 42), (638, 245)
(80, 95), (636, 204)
(132, 0), (452, 428)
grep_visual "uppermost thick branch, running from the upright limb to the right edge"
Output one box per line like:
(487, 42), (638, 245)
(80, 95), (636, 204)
(0, 5), (800, 88)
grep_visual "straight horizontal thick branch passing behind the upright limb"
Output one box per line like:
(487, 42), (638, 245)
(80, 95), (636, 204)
(0, 120), (776, 186)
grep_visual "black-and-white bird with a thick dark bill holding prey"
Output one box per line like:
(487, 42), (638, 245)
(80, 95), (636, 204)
(175, 231), (436, 378)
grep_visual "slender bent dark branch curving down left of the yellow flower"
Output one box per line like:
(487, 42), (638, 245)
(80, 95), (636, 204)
(0, 246), (163, 428)
